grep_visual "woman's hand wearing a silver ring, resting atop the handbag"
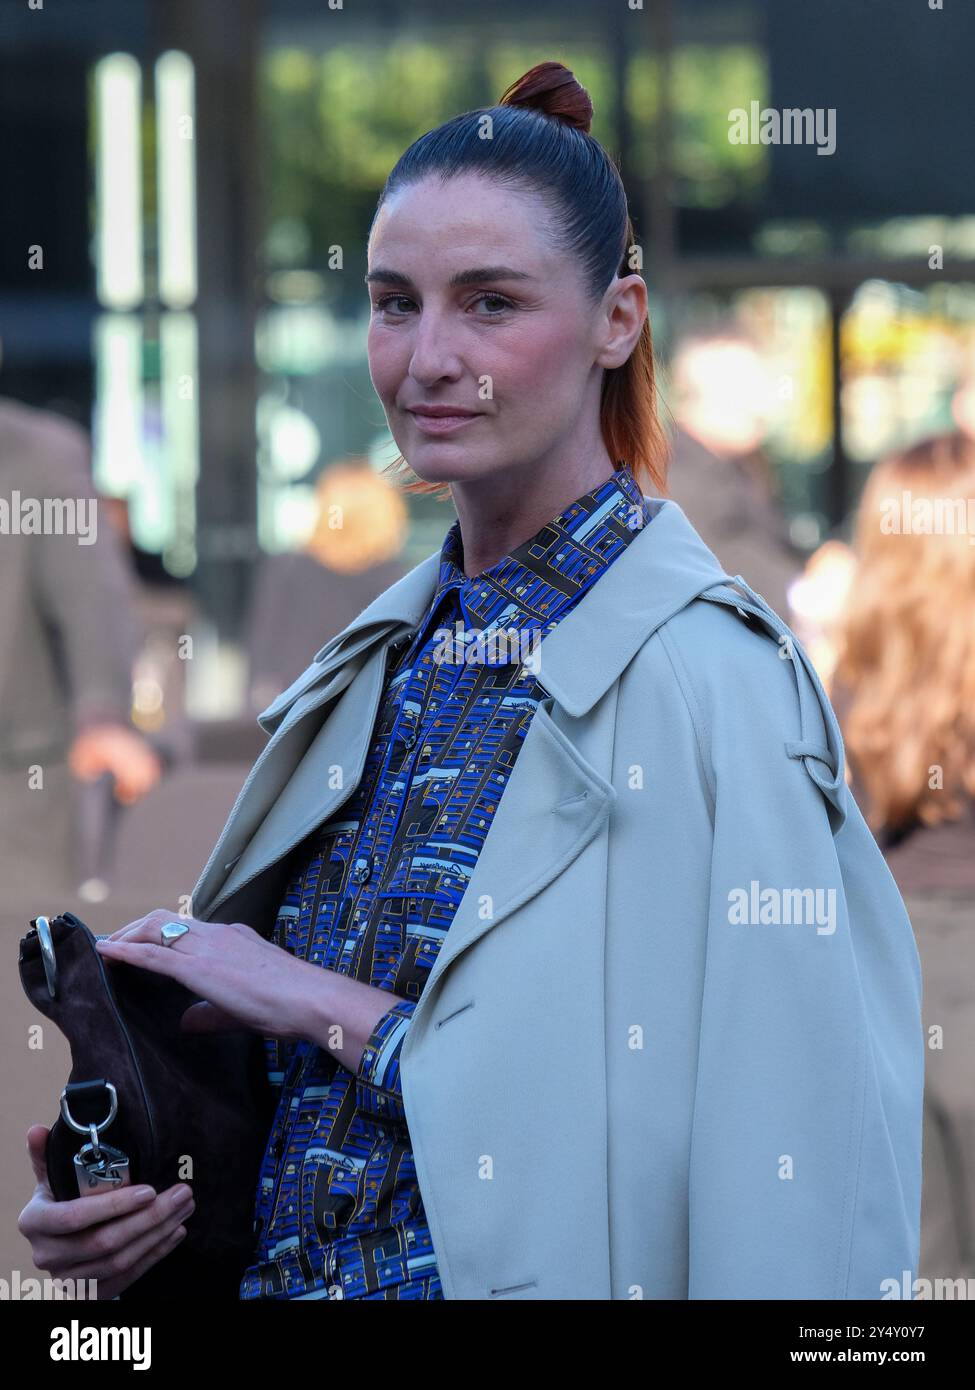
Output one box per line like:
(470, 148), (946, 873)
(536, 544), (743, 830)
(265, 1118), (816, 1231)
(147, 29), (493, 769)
(97, 908), (327, 1038)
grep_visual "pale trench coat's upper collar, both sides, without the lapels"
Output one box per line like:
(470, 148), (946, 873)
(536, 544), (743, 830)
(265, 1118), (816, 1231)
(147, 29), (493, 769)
(257, 498), (730, 734)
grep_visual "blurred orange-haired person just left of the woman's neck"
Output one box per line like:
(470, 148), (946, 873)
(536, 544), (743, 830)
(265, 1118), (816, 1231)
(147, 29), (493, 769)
(248, 460), (409, 712)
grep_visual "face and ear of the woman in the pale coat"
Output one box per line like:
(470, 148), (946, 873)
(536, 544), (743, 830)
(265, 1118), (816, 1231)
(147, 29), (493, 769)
(367, 175), (645, 482)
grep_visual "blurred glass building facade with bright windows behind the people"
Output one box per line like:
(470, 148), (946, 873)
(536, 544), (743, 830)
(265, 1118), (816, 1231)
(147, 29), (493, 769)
(0, 0), (975, 667)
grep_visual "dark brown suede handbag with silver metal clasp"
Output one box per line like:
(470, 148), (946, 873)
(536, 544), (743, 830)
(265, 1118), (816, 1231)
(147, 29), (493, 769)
(19, 912), (274, 1300)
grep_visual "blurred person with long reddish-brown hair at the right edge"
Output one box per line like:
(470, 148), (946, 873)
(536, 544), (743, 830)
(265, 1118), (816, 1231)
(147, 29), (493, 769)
(830, 434), (975, 1279)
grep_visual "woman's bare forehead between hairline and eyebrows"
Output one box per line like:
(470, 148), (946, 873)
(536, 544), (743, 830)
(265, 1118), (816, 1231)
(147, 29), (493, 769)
(369, 174), (561, 274)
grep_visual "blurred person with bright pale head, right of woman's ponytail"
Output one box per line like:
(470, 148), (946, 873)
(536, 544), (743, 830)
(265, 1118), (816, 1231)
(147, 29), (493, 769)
(663, 324), (800, 619)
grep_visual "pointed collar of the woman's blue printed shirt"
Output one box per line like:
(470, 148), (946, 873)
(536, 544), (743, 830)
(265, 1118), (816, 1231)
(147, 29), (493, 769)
(428, 464), (651, 627)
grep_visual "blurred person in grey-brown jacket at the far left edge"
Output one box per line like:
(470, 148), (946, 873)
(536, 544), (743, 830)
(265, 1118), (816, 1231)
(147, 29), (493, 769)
(0, 398), (161, 910)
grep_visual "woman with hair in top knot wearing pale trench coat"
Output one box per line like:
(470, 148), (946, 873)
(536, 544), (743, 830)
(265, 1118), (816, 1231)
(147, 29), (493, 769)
(21, 63), (924, 1298)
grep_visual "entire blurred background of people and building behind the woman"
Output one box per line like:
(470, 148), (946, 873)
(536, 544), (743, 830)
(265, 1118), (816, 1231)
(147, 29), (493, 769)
(0, 0), (975, 1277)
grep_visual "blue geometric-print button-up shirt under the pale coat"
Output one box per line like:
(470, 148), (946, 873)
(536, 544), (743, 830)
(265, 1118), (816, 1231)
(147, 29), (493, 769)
(241, 466), (650, 1300)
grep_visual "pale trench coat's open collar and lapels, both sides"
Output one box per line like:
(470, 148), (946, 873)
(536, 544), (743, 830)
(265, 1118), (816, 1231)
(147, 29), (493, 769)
(193, 499), (727, 978)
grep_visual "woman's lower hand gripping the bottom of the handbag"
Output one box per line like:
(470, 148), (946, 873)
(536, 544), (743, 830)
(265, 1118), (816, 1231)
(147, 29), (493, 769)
(17, 1125), (196, 1298)
